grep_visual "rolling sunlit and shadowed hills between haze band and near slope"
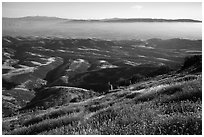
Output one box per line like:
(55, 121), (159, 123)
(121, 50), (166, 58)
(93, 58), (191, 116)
(2, 36), (202, 117)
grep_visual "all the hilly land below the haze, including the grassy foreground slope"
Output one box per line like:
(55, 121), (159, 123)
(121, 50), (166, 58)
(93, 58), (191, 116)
(2, 36), (202, 135)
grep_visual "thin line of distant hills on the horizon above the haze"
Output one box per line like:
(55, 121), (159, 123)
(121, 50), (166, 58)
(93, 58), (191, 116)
(3, 16), (202, 23)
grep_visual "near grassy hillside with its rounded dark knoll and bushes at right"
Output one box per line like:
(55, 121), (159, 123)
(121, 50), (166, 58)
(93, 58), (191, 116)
(3, 56), (202, 135)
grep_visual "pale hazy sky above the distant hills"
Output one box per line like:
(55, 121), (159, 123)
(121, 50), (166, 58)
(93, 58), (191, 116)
(2, 2), (202, 20)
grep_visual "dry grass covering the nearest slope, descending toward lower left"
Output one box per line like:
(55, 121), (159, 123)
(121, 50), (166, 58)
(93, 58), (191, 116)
(3, 74), (202, 135)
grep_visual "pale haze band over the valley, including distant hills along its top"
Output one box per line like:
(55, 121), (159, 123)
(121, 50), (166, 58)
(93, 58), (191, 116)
(3, 16), (202, 40)
